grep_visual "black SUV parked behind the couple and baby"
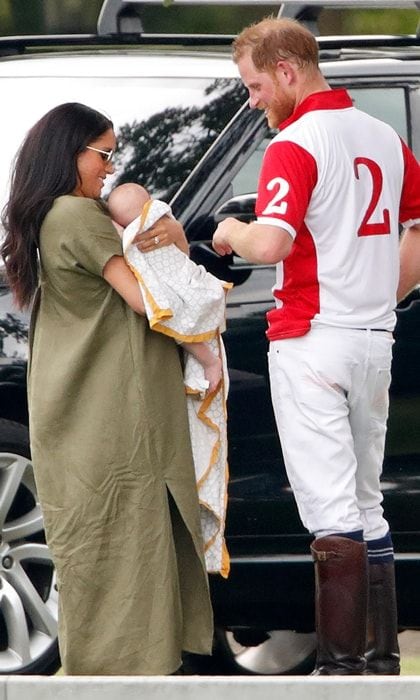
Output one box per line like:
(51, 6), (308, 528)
(0, 0), (420, 674)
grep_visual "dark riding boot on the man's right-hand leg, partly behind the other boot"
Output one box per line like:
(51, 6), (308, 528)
(365, 562), (400, 676)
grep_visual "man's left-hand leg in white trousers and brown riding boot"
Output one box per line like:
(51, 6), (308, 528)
(270, 329), (367, 675)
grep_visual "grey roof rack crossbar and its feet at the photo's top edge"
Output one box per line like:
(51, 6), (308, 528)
(97, 0), (420, 36)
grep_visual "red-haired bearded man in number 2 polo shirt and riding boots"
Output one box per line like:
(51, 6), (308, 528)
(213, 19), (420, 675)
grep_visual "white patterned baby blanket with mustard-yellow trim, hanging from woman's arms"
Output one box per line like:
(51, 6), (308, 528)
(123, 200), (231, 577)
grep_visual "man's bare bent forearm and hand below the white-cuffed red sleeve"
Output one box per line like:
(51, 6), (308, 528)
(213, 218), (293, 265)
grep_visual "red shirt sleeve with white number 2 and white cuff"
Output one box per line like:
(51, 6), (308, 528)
(255, 141), (318, 233)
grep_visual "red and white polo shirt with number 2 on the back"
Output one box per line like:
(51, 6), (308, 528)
(256, 90), (420, 340)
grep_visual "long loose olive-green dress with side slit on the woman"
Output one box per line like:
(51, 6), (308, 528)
(29, 195), (212, 675)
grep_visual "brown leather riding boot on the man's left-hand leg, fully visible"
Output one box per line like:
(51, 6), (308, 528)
(311, 535), (368, 676)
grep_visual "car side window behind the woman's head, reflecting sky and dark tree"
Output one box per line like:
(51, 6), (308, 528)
(0, 75), (244, 213)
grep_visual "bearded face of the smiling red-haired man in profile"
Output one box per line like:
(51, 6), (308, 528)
(238, 53), (296, 129)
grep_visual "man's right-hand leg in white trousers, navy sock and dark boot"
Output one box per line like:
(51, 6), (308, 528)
(349, 332), (400, 675)
